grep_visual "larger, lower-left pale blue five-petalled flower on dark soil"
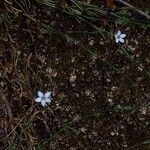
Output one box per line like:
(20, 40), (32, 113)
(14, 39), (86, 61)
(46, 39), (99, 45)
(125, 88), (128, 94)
(35, 91), (52, 106)
